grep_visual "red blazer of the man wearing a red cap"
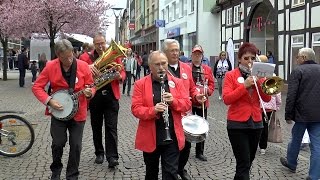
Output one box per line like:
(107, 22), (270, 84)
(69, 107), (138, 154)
(191, 64), (214, 108)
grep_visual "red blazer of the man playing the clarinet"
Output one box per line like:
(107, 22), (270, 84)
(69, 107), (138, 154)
(131, 75), (191, 152)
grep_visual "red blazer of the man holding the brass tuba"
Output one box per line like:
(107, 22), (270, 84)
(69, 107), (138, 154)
(81, 51), (126, 100)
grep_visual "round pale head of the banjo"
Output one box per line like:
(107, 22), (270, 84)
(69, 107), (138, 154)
(51, 91), (74, 120)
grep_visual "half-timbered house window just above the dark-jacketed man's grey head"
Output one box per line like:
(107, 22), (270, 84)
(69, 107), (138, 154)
(290, 35), (304, 71)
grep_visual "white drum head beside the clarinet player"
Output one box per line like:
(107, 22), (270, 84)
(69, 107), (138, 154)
(182, 115), (209, 135)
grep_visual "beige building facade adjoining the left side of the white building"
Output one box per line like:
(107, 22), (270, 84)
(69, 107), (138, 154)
(130, 0), (159, 53)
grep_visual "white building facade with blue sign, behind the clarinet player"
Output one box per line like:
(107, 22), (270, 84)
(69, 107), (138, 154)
(159, 0), (220, 62)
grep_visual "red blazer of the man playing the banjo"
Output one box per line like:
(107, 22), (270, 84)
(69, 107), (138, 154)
(32, 59), (95, 121)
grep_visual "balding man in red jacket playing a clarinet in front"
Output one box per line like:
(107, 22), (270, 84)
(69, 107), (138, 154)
(131, 51), (191, 180)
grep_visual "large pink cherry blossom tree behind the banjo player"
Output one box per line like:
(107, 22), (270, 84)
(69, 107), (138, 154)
(29, 0), (110, 58)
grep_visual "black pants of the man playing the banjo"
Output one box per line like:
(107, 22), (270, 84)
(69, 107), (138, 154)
(50, 117), (85, 179)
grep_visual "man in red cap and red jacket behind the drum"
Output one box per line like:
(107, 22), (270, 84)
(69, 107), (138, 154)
(191, 45), (214, 161)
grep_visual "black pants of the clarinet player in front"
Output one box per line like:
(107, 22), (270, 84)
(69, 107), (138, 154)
(143, 141), (179, 180)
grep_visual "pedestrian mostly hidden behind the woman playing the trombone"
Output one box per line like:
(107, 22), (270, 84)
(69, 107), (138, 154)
(259, 55), (282, 155)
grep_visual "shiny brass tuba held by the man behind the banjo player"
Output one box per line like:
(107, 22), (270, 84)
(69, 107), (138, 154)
(94, 40), (127, 90)
